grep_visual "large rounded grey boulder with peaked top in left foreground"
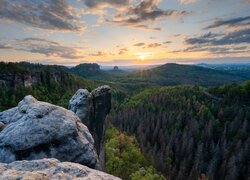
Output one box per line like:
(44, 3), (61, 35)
(0, 96), (97, 167)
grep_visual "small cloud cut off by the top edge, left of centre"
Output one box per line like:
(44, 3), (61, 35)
(82, 0), (129, 8)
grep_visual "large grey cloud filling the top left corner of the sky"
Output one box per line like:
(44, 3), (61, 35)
(0, 0), (84, 32)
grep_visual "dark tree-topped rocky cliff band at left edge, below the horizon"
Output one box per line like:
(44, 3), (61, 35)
(0, 62), (73, 89)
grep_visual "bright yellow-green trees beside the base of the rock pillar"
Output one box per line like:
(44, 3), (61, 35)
(105, 126), (163, 179)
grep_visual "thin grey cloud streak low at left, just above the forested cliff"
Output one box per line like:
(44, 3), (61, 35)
(11, 38), (84, 59)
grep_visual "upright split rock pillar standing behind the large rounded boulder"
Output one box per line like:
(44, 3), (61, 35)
(69, 85), (111, 155)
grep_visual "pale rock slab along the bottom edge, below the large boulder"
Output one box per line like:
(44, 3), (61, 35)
(0, 159), (119, 180)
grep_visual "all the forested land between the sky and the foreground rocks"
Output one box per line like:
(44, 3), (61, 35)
(0, 62), (250, 180)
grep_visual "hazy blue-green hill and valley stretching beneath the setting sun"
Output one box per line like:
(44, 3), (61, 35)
(71, 64), (248, 95)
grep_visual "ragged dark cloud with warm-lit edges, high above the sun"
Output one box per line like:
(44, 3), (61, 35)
(107, 0), (188, 30)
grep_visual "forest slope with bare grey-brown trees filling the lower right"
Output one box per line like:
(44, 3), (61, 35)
(108, 82), (250, 179)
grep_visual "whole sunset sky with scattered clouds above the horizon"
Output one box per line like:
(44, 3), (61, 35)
(0, 0), (250, 66)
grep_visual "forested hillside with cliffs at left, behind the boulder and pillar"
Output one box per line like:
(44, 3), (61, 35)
(0, 62), (98, 111)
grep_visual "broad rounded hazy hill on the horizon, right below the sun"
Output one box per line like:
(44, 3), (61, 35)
(127, 64), (247, 86)
